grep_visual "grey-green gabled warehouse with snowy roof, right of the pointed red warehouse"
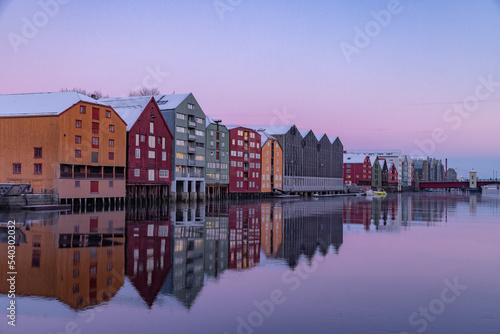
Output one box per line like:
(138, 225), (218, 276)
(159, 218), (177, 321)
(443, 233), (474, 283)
(155, 93), (205, 201)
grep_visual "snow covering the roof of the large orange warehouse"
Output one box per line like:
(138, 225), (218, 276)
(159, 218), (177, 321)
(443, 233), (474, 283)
(0, 92), (105, 117)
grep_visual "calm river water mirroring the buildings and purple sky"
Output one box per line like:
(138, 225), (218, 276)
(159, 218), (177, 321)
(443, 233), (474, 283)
(0, 192), (500, 334)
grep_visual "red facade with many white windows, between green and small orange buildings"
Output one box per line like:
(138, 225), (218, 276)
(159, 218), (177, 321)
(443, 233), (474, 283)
(229, 127), (262, 193)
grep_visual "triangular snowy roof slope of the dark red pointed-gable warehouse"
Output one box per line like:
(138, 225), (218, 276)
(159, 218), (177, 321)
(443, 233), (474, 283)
(99, 96), (152, 131)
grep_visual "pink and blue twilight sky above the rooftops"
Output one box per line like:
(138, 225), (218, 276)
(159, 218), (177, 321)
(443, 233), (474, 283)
(0, 0), (500, 178)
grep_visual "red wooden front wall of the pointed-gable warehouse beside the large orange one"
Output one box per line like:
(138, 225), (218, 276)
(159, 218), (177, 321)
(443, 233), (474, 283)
(127, 99), (172, 185)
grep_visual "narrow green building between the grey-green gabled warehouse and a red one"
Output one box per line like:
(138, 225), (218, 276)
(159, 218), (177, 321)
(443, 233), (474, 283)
(205, 116), (229, 198)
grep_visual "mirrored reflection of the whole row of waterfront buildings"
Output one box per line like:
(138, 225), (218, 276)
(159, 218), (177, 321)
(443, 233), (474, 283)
(0, 193), (498, 310)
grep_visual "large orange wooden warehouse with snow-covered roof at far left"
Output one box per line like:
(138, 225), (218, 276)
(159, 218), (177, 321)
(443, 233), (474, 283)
(0, 92), (126, 205)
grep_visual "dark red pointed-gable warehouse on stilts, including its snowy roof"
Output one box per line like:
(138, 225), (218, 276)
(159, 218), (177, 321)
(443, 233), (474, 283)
(99, 96), (172, 199)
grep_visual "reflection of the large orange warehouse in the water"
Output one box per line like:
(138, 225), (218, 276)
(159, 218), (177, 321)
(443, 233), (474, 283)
(0, 211), (125, 310)
